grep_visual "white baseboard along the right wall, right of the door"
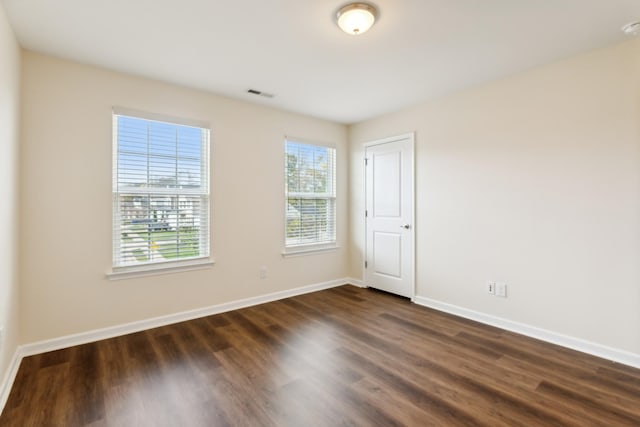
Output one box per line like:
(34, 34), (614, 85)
(413, 296), (640, 368)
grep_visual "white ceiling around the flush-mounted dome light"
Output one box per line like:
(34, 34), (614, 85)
(0, 0), (640, 123)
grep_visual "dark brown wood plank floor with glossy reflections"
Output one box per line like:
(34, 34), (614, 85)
(0, 286), (640, 427)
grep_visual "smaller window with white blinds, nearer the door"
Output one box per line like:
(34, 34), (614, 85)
(285, 141), (336, 253)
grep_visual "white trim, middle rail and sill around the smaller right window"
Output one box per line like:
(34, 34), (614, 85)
(281, 136), (339, 258)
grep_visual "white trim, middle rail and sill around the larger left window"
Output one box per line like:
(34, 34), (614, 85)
(106, 106), (210, 280)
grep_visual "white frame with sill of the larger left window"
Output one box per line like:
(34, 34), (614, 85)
(107, 107), (214, 280)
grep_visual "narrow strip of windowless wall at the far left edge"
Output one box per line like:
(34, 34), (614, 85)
(0, 5), (20, 381)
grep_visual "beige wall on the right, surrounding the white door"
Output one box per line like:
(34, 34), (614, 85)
(350, 40), (640, 354)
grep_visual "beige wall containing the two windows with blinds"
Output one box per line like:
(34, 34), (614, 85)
(20, 52), (348, 343)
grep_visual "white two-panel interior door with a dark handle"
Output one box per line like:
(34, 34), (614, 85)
(364, 134), (414, 298)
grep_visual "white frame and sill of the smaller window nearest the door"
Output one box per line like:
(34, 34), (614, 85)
(282, 137), (338, 257)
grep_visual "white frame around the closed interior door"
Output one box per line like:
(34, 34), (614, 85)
(362, 131), (416, 302)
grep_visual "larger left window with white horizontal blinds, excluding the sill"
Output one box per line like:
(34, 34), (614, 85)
(113, 110), (209, 268)
